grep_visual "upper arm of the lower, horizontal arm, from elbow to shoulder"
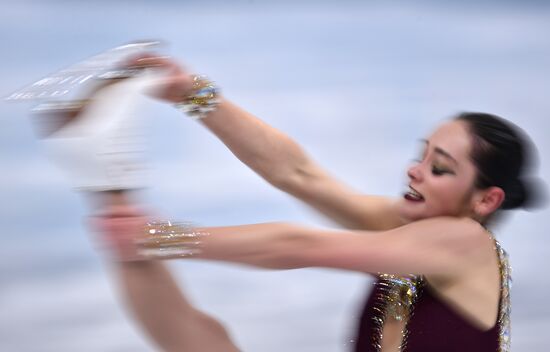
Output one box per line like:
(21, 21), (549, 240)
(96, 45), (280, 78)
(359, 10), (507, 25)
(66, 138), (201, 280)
(299, 218), (489, 277)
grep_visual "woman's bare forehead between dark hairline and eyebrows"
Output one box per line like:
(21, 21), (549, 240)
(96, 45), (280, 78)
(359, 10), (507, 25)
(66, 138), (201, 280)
(428, 121), (472, 160)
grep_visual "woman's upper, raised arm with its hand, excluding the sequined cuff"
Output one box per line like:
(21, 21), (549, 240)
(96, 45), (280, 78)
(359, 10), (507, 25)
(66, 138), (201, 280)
(134, 57), (402, 230)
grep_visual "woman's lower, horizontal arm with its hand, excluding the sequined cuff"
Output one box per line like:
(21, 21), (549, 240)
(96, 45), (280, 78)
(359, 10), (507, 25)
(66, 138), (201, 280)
(99, 206), (491, 276)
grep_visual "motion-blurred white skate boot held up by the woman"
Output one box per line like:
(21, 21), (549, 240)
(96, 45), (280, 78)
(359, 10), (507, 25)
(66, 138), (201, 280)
(43, 71), (159, 191)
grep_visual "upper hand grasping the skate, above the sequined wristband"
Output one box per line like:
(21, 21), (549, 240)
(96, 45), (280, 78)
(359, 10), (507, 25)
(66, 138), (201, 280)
(127, 54), (193, 103)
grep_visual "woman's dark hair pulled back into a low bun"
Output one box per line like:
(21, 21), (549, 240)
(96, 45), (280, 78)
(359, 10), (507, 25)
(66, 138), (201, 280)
(455, 112), (536, 209)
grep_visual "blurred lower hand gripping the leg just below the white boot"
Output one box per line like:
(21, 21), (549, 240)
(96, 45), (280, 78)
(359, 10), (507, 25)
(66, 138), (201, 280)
(89, 205), (150, 261)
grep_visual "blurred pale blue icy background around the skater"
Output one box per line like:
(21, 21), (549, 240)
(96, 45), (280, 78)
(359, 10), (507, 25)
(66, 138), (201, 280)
(0, 0), (550, 352)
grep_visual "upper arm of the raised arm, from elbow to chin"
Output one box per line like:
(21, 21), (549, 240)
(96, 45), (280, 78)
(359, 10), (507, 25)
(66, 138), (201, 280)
(279, 163), (404, 231)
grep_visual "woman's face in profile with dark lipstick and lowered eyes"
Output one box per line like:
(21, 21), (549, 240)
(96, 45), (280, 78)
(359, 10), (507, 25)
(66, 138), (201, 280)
(399, 121), (484, 221)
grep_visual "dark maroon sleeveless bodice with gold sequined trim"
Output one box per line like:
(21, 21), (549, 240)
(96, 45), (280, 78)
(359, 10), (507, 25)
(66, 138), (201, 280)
(355, 236), (511, 352)
